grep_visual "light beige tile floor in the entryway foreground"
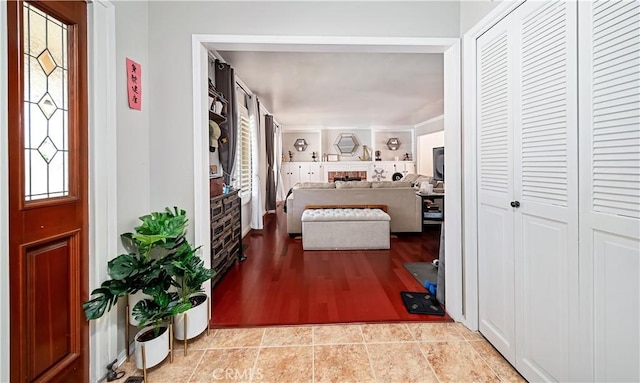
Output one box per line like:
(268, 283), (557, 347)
(119, 323), (525, 383)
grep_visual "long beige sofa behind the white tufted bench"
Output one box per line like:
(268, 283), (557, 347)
(286, 181), (422, 235)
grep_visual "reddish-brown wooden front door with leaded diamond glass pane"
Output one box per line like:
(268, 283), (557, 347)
(7, 1), (89, 382)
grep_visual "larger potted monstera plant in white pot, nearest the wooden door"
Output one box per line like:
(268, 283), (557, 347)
(83, 208), (198, 368)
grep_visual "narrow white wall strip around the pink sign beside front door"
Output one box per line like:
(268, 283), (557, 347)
(111, 1), (151, 356)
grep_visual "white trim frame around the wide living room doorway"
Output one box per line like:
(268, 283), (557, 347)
(192, 35), (464, 321)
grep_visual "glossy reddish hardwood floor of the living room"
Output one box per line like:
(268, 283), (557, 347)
(212, 206), (451, 327)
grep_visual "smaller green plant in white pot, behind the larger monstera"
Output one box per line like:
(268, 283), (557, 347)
(169, 242), (215, 340)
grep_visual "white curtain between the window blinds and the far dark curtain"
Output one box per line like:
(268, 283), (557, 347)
(247, 95), (264, 230)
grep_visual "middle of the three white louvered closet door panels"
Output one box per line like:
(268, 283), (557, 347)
(513, 1), (579, 382)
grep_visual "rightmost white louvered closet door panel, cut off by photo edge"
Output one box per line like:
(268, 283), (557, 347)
(578, 1), (640, 382)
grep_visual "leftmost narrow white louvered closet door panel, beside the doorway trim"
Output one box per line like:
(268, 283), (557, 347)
(476, 8), (515, 363)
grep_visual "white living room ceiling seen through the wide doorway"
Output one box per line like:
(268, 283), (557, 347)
(212, 51), (444, 128)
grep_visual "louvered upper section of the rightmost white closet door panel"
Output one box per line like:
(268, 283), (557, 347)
(591, 1), (640, 218)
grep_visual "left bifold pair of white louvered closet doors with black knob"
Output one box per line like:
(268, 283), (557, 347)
(477, 1), (578, 381)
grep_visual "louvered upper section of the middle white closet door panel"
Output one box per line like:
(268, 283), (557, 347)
(522, 2), (568, 206)
